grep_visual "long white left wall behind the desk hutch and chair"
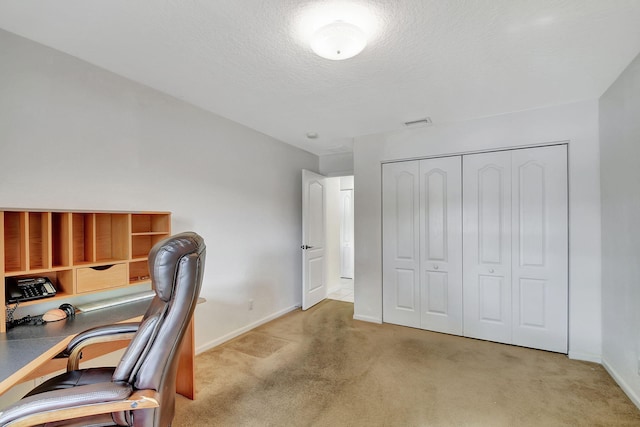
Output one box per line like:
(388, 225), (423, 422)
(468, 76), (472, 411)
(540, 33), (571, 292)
(0, 30), (319, 350)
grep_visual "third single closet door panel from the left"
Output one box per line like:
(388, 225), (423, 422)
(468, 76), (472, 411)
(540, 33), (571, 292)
(463, 151), (512, 343)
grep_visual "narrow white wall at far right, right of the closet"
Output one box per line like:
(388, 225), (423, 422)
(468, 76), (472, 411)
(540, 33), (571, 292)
(600, 51), (640, 407)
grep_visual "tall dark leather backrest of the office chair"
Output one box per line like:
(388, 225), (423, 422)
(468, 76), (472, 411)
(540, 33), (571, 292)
(113, 232), (206, 427)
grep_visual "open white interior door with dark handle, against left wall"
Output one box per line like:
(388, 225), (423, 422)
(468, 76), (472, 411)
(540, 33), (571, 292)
(301, 170), (327, 310)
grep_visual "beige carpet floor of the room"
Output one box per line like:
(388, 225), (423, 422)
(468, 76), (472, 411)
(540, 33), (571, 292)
(173, 301), (640, 427)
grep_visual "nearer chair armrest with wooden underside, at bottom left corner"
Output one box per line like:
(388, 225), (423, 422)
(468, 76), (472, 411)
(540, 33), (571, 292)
(0, 382), (159, 427)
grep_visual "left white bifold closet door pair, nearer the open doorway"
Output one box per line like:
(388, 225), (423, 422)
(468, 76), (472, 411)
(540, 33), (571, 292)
(383, 156), (462, 335)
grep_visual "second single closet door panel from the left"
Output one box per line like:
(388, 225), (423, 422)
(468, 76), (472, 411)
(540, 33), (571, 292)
(420, 156), (462, 335)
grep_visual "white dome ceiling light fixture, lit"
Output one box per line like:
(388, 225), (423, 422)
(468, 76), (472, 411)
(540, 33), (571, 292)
(311, 21), (367, 61)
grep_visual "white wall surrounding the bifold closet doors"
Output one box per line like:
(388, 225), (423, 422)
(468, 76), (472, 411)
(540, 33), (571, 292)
(354, 100), (601, 361)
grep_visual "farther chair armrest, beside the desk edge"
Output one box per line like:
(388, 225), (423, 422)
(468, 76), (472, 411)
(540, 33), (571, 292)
(64, 322), (140, 371)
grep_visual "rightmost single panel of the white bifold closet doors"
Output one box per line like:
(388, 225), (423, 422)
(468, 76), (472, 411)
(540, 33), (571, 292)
(512, 145), (568, 353)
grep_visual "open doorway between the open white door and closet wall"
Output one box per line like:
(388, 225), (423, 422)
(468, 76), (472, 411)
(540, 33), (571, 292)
(325, 175), (354, 303)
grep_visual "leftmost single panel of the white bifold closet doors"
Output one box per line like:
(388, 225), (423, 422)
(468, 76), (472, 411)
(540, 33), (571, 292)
(382, 161), (420, 328)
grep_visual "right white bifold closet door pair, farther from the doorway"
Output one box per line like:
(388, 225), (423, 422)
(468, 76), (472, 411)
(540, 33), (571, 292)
(463, 145), (568, 353)
